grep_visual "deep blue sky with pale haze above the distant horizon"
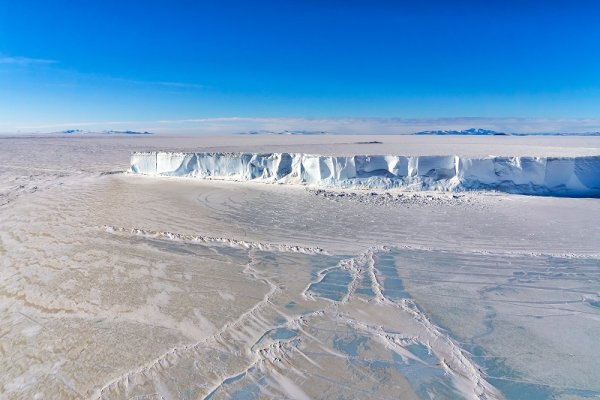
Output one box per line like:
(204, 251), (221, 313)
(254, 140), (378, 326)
(0, 0), (600, 133)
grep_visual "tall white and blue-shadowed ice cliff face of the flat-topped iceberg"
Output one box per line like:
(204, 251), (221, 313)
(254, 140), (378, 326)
(131, 152), (600, 197)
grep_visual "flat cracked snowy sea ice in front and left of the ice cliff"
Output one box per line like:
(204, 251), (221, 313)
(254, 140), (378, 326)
(0, 138), (600, 399)
